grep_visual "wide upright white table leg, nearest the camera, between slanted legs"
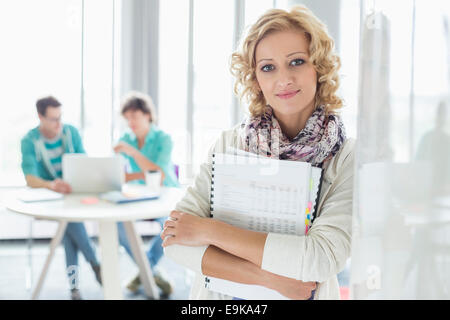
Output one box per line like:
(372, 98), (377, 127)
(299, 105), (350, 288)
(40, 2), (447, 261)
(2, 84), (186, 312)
(99, 221), (123, 300)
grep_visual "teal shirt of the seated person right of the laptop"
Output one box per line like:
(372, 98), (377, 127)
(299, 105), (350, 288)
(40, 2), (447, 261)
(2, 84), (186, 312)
(120, 124), (179, 187)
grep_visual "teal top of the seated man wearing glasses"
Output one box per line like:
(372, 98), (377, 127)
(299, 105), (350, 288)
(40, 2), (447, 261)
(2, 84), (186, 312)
(21, 124), (86, 180)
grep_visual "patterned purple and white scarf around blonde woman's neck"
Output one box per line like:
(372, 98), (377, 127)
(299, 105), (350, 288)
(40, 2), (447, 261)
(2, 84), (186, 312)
(241, 105), (345, 167)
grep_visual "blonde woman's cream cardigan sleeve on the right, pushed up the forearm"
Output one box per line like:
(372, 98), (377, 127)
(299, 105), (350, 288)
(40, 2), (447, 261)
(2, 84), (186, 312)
(261, 141), (354, 282)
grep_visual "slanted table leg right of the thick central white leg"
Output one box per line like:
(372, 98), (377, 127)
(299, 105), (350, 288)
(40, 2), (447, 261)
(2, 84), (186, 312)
(123, 221), (159, 299)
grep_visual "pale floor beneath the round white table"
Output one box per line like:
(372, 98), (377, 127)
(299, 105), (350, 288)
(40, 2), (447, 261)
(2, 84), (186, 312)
(0, 238), (193, 300)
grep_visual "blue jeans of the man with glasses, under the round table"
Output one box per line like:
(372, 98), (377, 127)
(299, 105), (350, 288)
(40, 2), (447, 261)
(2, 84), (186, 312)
(63, 222), (99, 288)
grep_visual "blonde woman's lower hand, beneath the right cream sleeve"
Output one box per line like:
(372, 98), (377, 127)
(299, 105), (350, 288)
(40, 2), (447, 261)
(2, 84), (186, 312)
(263, 272), (316, 300)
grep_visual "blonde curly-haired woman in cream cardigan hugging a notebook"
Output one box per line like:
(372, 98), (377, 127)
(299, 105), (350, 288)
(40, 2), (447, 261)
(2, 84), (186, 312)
(161, 6), (354, 299)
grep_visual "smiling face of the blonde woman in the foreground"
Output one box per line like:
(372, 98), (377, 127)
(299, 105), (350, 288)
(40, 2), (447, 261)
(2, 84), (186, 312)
(255, 30), (317, 117)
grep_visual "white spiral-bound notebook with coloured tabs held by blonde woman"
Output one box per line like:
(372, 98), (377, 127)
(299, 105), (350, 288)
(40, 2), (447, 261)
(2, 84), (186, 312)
(205, 151), (322, 300)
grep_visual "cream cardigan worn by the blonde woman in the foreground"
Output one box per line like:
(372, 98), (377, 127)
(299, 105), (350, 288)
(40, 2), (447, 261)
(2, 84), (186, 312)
(164, 126), (355, 299)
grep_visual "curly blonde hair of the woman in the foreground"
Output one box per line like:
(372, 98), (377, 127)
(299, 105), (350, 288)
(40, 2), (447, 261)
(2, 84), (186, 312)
(230, 6), (343, 116)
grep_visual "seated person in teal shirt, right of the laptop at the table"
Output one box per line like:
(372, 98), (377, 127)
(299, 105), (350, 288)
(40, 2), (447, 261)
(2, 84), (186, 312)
(114, 92), (179, 295)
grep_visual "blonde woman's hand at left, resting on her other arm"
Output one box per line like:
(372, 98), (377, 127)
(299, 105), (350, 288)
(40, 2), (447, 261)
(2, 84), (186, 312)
(161, 211), (214, 247)
